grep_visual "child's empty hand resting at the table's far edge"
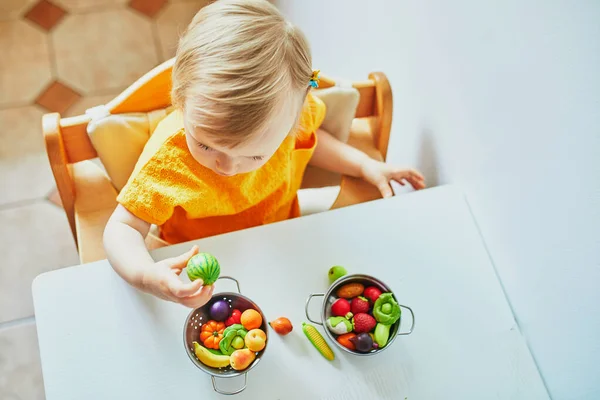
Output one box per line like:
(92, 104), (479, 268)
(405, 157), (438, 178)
(361, 159), (425, 197)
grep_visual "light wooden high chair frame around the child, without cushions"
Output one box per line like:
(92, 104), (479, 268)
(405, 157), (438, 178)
(42, 59), (392, 263)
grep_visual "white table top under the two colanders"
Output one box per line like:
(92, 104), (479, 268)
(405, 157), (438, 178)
(33, 186), (548, 400)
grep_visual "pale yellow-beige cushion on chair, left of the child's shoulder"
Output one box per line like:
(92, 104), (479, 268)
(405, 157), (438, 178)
(87, 106), (171, 191)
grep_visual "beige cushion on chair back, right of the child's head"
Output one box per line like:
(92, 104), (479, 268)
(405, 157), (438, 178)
(314, 86), (360, 143)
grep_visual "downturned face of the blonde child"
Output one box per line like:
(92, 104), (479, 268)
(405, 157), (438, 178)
(184, 93), (304, 176)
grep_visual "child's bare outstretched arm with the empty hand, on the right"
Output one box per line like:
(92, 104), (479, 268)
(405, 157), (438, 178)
(310, 129), (425, 197)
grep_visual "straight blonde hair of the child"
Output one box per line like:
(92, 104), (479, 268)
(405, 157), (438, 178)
(172, 0), (312, 147)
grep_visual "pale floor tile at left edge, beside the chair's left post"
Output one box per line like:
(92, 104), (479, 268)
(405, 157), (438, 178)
(0, 106), (54, 205)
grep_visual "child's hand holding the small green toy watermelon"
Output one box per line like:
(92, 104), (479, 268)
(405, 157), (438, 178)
(142, 246), (213, 308)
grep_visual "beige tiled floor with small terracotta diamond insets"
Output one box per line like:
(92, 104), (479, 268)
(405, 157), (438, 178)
(0, 0), (208, 400)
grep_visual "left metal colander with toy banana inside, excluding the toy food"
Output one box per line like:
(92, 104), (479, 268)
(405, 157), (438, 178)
(183, 276), (269, 395)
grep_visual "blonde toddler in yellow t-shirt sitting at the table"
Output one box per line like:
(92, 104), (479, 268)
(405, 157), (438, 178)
(104, 0), (424, 307)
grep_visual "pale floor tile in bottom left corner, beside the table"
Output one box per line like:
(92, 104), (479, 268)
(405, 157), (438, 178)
(0, 322), (45, 400)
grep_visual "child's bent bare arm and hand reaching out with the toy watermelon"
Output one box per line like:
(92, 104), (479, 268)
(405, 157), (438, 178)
(104, 204), (213, 308)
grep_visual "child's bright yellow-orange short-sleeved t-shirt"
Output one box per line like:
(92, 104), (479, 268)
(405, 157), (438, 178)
(117, 93), (325, 243)
